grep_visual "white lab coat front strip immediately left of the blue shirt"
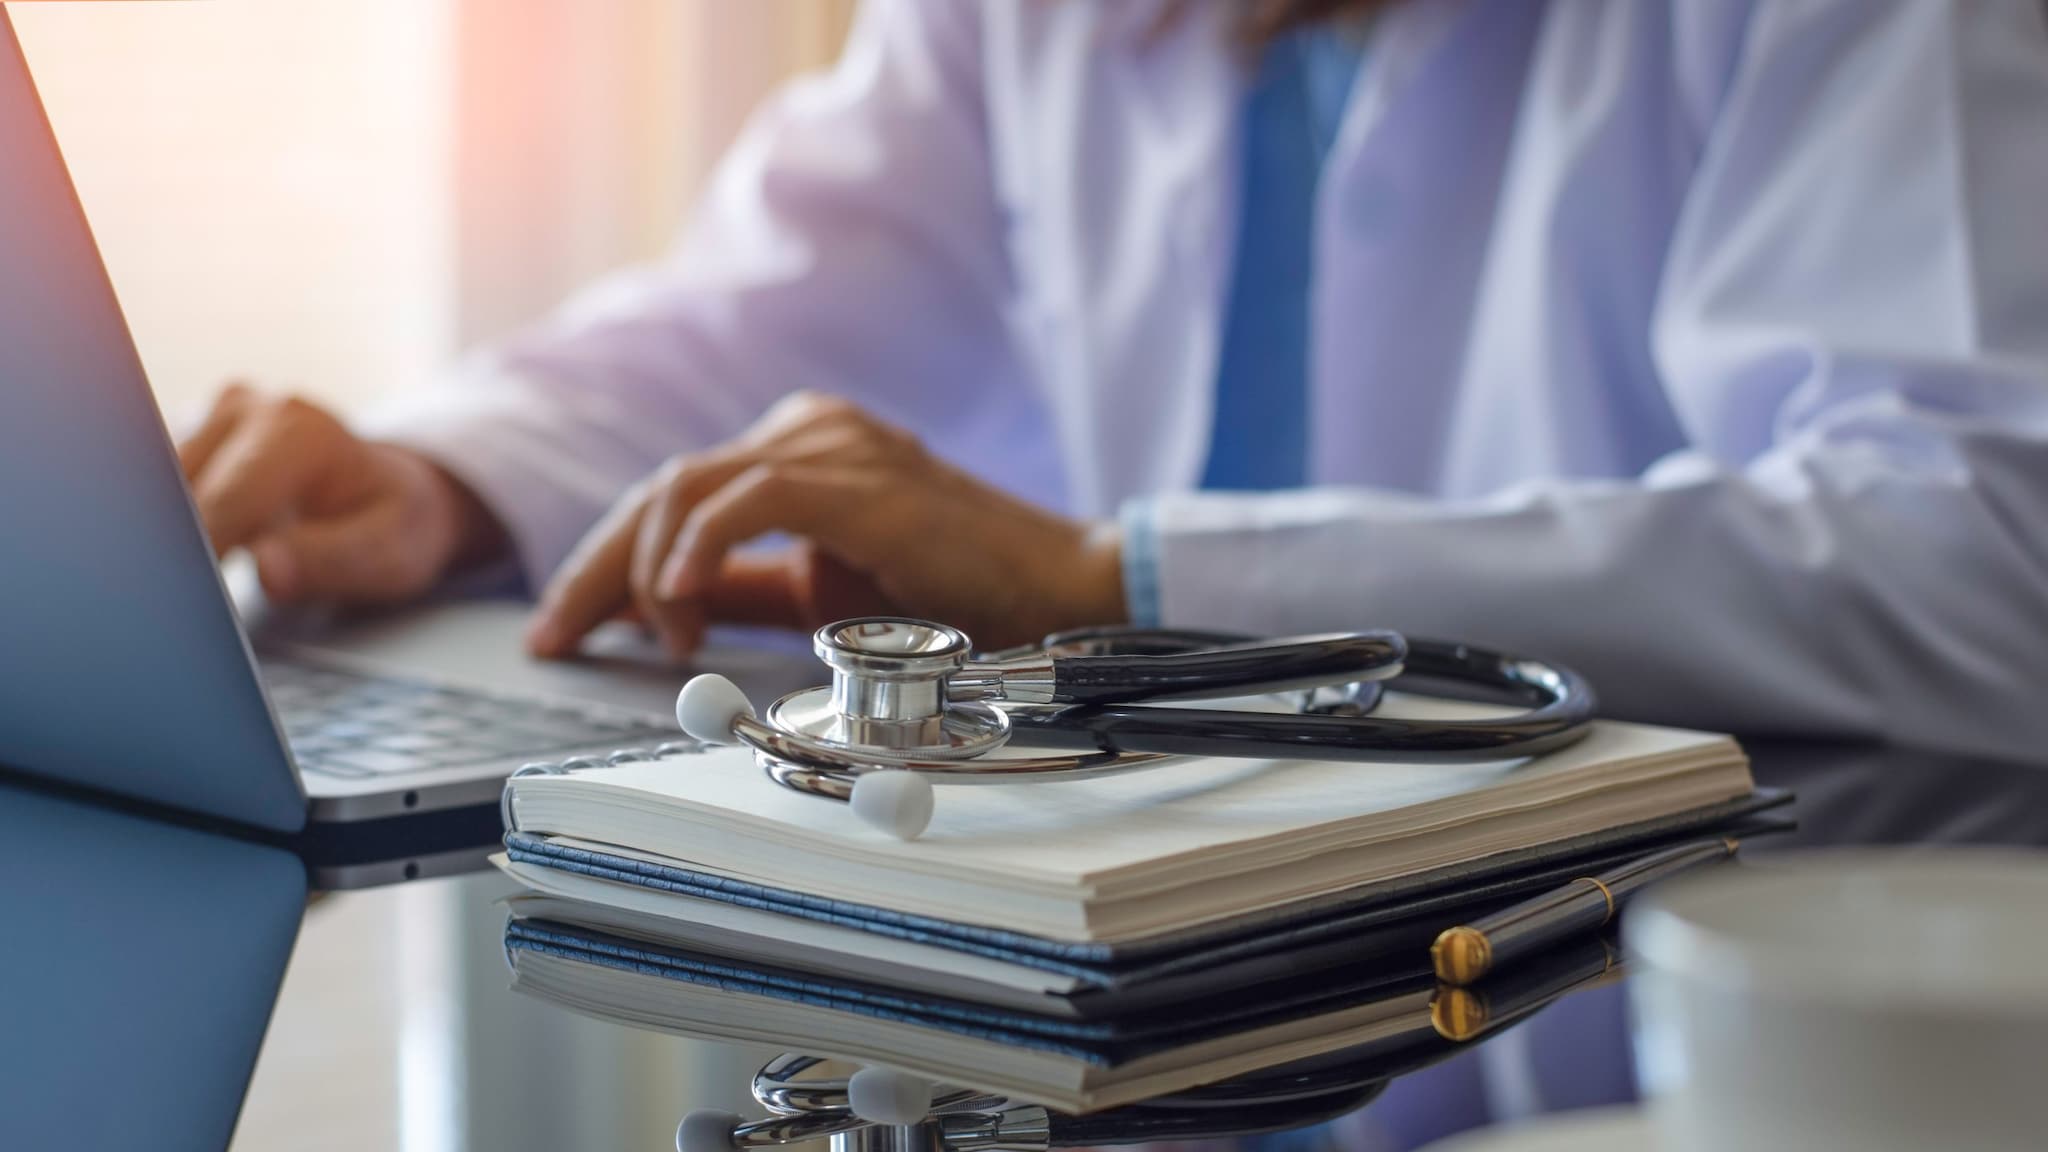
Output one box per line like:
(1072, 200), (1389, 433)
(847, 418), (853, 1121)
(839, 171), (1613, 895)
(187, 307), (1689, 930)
(1040, 0), (1243, 504)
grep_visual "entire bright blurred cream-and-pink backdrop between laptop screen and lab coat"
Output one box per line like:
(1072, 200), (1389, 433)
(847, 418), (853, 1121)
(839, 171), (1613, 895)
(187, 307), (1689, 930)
(12, 0), (854, 414)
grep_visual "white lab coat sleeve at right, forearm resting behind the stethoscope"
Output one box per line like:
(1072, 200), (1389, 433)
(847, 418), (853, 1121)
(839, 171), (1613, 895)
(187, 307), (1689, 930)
(1137, 0), (2048, 756)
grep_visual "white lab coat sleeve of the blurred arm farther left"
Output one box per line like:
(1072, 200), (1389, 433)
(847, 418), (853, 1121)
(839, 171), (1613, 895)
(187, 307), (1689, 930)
(365, 0), (1057, 586)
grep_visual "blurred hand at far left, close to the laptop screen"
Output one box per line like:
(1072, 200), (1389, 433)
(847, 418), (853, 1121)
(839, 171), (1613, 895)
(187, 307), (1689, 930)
(178, 385), (504, 603)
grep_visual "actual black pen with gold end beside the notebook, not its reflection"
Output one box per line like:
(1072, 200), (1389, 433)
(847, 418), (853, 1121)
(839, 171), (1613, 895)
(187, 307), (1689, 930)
(1430, 836), (1739, 986)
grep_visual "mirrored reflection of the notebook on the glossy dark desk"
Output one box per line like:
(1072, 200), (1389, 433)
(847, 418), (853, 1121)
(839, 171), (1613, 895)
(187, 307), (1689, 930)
(506, 916), (1614, 1111)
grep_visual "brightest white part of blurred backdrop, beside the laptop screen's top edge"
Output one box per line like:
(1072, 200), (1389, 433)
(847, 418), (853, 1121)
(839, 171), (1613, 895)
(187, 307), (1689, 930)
(10, 0), (455, 424)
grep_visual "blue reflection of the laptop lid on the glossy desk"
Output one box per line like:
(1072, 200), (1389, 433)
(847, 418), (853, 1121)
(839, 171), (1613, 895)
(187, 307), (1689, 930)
(0, 783), (305, 1150)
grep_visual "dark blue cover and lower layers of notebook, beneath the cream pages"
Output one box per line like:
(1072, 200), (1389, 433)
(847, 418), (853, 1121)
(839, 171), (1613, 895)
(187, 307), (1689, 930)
(494, 789), (1792, 1019)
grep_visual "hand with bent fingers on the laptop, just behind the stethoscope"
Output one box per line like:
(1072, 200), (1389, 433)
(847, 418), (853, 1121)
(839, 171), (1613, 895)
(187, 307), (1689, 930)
(528, 394), (1126, 658)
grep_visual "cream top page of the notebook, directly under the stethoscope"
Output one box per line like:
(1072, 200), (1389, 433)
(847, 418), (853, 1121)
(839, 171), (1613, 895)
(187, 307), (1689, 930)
(518, 722), (1739, 890)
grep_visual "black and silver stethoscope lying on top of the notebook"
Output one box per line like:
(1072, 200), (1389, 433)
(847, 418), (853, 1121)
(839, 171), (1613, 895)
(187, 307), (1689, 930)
(676, 617), (1593, 838)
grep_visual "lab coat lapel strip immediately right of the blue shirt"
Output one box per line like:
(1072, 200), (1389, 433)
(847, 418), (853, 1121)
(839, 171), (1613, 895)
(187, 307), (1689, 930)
(1309, 0), (1542, 490)
